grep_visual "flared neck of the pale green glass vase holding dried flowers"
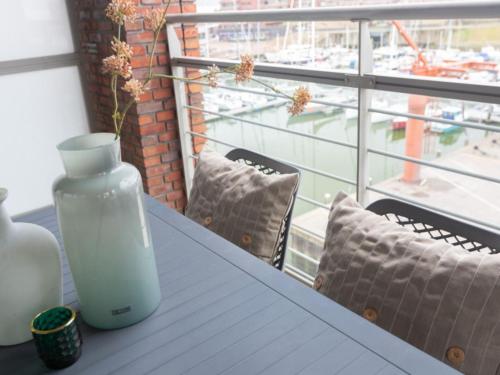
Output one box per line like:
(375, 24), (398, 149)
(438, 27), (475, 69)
(57, 133), (121, 177)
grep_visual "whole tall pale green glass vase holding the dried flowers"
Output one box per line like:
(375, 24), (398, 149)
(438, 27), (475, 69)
(53, 133), (161, 329)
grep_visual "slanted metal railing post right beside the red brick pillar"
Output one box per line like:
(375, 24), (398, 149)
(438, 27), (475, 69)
(167, 25), (194, 198)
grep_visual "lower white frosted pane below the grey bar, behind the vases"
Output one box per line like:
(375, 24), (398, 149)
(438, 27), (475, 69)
(0, 67), (89, 215)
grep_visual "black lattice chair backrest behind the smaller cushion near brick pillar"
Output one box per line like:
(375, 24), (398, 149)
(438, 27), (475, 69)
(226, 148), (300, 270)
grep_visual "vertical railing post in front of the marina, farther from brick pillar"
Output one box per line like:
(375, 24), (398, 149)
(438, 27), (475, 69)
(356, 20), (373, 206)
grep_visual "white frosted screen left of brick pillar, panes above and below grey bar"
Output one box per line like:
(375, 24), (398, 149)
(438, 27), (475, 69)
(0, 0), (89, 215)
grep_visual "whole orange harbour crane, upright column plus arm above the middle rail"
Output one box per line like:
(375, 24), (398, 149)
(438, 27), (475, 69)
(392, 21), (496, 183)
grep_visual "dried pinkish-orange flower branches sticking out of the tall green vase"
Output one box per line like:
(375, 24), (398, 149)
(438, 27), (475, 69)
(102, 0), (311, 138)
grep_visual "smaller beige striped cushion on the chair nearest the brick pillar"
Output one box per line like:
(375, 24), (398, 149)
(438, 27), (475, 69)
(186, 151), (299, 263)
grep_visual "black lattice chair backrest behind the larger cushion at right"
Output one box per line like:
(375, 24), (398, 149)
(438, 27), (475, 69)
(366, 199), (500, 254)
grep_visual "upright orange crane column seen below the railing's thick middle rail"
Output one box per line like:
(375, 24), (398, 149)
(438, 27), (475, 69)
(403, 95), (428, 183)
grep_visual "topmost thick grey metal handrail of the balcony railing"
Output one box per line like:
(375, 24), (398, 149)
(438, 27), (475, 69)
(167, 1), (500, 24)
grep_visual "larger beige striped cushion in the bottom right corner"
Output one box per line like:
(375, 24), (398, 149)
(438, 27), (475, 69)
(314, 193), (500, 375)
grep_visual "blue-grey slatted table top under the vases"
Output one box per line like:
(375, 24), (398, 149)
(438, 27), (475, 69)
(0, 197), (457, 375)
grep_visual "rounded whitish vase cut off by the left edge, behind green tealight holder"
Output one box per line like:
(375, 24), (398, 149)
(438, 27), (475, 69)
(0, 188), (62, 345)
